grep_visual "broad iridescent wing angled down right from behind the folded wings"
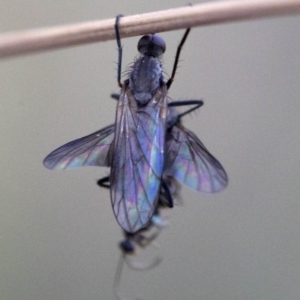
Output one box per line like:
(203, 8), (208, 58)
(164, 126), (228, 193)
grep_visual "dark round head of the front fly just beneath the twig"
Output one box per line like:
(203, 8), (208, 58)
(137, 34), (166, 58)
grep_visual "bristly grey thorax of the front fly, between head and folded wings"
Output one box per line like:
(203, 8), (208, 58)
(129, 56), (163, 105)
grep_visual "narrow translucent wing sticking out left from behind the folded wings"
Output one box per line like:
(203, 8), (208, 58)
(43, 125), (115, 170)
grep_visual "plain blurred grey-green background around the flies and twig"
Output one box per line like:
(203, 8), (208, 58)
(0, 0), (300, 300)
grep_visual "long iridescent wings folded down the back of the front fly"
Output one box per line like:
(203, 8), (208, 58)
(110, 85), (167, 233)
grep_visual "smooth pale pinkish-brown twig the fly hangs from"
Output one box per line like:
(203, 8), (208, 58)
(0, 0), (300, 57)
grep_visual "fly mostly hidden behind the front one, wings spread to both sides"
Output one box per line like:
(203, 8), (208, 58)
(44, 98), (228, 223)
